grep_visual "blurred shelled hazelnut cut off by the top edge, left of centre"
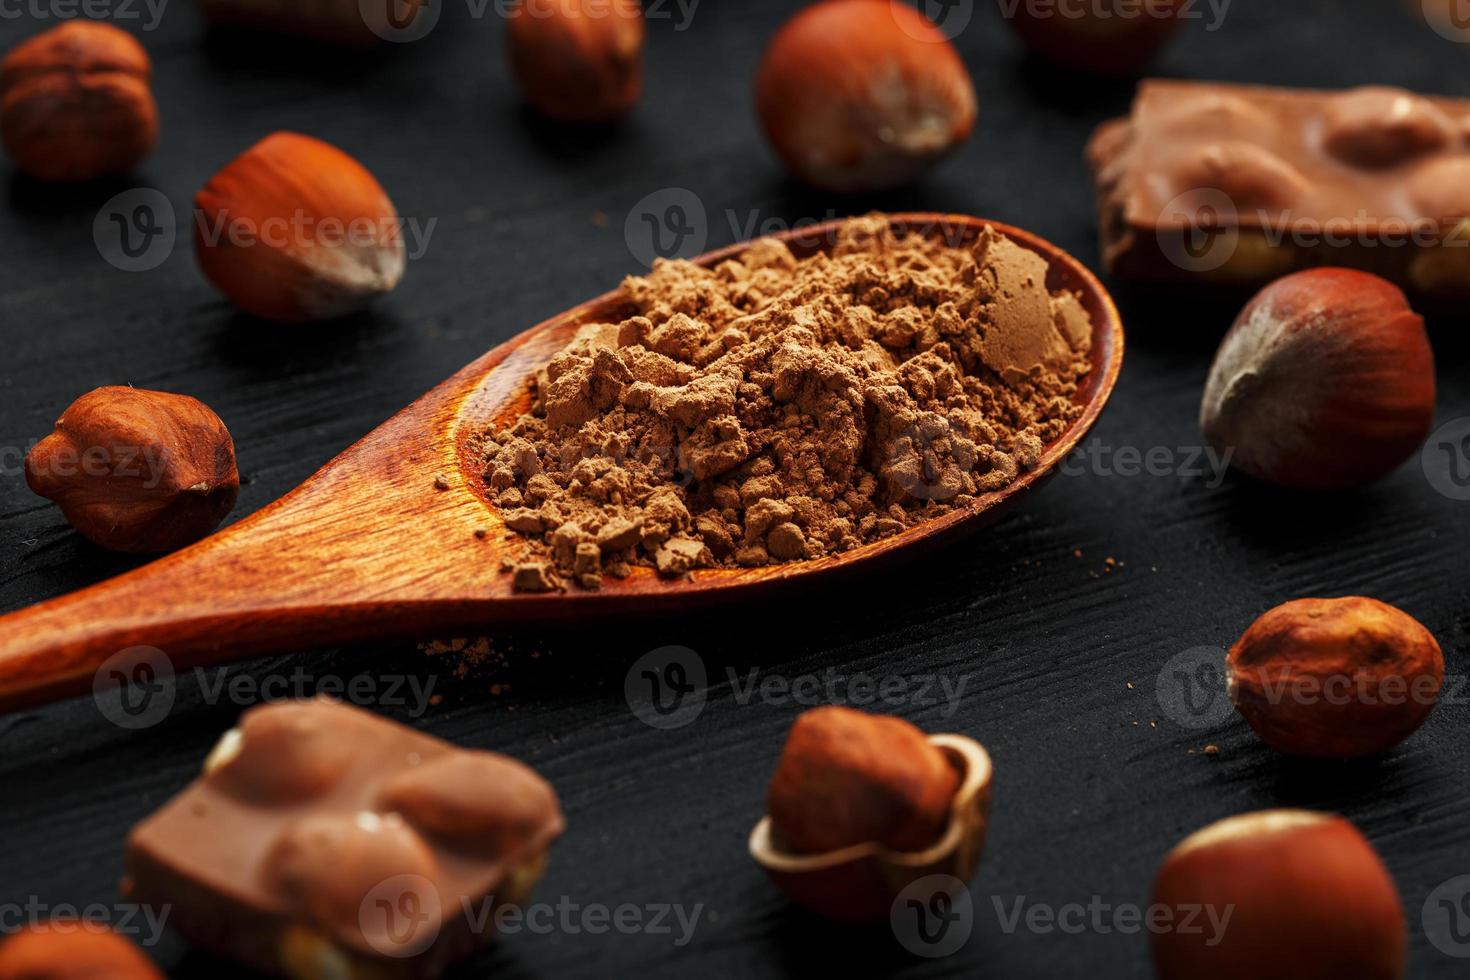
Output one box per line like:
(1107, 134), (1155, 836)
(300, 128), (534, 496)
(506, 0), (644, 122)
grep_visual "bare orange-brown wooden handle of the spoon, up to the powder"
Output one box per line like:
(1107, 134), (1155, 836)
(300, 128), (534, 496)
(0, 437), (515, 713)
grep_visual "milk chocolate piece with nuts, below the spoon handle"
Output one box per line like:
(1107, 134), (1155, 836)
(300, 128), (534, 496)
(123, 698), (563, 980)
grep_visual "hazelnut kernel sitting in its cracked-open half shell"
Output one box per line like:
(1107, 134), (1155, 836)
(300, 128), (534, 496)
(750, 707), (992, 923)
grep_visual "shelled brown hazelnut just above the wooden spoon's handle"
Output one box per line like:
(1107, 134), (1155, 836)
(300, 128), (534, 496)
(25, 388), (240, 552)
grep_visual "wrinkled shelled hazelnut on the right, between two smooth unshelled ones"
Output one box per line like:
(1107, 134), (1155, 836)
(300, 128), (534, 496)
(1226, 597), (1445, 758)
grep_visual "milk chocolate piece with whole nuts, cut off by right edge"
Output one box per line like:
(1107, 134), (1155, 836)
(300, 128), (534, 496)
(1088, 81), (1470, 301)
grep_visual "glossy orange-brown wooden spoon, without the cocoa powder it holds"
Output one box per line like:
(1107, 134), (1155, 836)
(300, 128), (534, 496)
(0, 213), (1123, 710)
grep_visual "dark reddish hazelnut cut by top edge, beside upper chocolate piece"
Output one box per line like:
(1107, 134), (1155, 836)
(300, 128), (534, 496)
(1001, 0), (1185, 75)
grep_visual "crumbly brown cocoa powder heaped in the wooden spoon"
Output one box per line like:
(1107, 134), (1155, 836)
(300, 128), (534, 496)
(485, 215), (1091, 591)
